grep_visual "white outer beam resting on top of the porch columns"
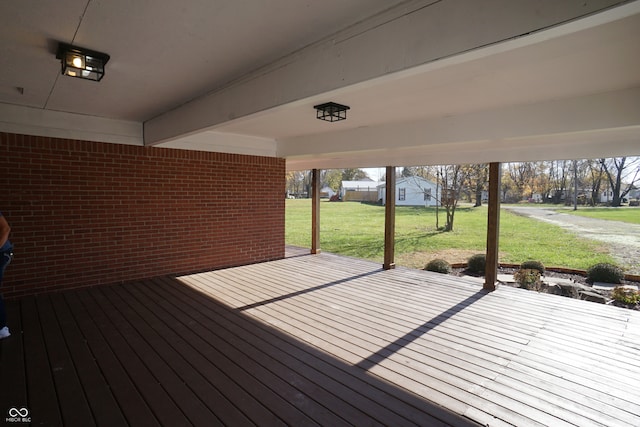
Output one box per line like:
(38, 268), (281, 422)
(278, 87), (640, 170)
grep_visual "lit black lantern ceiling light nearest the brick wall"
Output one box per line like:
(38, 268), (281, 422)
(56, 43), (109, 82)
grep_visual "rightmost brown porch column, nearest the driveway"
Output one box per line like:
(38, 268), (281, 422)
(483, 163), (502, 291)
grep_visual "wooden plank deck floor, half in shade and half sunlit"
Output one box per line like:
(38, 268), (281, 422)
(0, 251), (640, 427)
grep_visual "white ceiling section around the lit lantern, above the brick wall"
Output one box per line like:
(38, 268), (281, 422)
(0, 0), (401, 122)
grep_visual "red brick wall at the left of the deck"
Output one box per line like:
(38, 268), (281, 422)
(0, 133), (285, 298)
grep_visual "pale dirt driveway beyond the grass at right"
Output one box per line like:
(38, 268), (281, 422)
(503, 206), (640, 274)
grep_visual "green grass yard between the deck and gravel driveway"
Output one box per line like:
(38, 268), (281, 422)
(285, 199), (613, 269)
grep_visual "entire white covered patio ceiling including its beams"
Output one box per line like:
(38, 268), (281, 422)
(0, 0), (640, 170)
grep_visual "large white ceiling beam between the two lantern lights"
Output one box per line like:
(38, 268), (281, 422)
(144, 0), (625, 145)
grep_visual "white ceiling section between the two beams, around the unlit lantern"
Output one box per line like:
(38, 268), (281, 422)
(216, 14), (640, 139)
